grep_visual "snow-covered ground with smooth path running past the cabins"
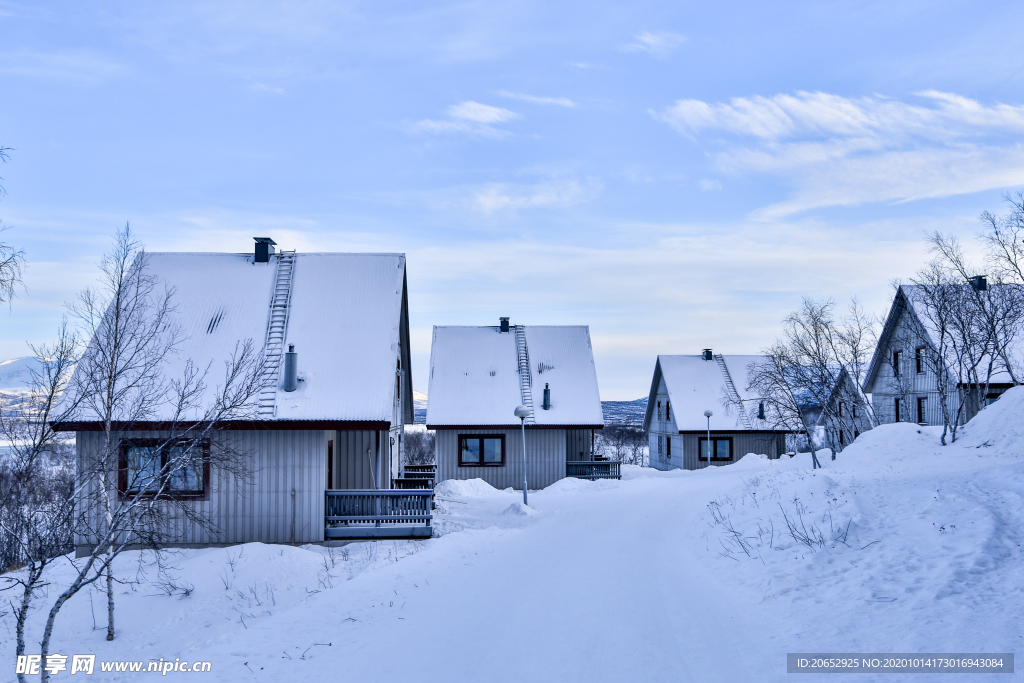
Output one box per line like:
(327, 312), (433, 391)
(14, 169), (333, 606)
(8, 388), (1024, 682)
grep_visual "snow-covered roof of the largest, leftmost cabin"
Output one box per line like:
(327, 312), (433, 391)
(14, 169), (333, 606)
(60, 253), (412, 423)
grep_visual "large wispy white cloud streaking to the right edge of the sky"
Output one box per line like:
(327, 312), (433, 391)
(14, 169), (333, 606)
(651, 91), (1024, 217)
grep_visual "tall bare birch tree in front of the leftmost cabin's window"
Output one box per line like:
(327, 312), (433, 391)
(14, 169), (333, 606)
(34, 226), (262, 680)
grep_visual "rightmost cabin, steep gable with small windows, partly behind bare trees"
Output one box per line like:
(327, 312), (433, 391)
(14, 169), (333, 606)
(862, 284), (1019, 426)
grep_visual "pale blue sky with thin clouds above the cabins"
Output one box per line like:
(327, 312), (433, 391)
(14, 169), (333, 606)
(0, 1), (1024, 398)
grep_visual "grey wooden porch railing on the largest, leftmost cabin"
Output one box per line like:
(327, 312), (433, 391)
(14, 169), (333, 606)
(324, 488), (434, 538)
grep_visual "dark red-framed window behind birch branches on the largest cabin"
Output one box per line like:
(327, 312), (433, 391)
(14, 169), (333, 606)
(118, 439), (210, 500)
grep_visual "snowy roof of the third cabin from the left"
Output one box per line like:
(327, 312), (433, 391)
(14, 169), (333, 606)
(644, 354), (786, 431)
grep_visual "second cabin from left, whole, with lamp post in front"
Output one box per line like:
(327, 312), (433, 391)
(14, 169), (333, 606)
(427, 317), (620, 489)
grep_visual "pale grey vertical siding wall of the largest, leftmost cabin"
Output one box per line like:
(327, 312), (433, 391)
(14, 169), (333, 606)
(76, 430), (390, 546)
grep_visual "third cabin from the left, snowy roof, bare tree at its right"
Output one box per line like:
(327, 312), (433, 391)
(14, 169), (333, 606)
(643, 349), (793, 470)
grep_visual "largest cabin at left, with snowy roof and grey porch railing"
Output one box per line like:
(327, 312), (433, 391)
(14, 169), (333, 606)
(57, 238), (432, 553)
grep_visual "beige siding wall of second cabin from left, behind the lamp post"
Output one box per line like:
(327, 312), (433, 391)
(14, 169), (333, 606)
(434, 428), (569, 490)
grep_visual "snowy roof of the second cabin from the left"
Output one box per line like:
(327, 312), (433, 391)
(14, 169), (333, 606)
(427, 326), (604, 428)
